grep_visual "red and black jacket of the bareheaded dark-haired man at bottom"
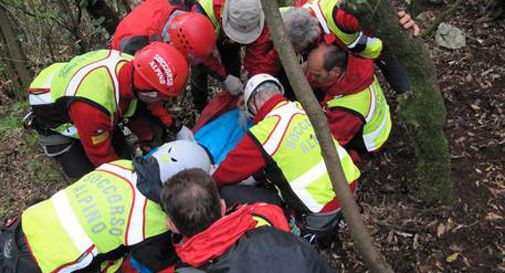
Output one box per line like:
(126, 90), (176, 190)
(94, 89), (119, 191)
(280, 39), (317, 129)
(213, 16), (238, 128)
(175, 203), (334, 273)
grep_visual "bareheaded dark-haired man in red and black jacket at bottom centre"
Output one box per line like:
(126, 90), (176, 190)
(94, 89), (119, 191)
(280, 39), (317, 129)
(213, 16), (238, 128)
(161, 169), (335, 273)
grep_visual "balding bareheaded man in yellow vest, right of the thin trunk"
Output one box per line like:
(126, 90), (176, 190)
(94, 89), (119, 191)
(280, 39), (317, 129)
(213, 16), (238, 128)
(307, 44), (392, 160)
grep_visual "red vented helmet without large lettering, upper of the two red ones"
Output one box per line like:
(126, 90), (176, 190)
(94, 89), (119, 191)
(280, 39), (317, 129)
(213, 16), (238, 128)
(168, 12), (216, 64)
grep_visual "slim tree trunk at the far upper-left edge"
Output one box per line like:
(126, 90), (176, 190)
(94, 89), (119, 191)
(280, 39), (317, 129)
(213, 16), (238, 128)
(0, 5), (32, 98)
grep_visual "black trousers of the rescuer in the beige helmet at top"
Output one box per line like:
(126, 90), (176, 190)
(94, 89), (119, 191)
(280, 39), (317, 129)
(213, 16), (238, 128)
(191, 39), (242, 112)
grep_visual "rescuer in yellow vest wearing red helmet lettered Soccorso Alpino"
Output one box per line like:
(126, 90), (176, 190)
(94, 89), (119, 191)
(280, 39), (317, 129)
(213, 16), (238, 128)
(29, 42), (188, 178)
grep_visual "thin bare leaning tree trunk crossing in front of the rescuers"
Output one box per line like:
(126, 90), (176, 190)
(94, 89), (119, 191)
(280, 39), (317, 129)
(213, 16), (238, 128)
(261, 0), (393, 273)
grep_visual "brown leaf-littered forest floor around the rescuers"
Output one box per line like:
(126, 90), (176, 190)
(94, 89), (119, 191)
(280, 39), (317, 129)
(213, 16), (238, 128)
(0, 0), (505, 273)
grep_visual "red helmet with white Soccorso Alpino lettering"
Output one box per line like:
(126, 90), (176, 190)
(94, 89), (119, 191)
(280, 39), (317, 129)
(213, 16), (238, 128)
(133, 42), (189, 97)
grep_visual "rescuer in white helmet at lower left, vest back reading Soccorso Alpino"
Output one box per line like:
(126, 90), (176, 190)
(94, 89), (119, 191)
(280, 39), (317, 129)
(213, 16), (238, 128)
(0, 140), (211, 273)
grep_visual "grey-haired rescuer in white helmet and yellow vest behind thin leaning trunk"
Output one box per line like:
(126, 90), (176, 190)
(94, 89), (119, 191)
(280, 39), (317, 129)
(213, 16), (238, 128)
(213, 74), (360, 240)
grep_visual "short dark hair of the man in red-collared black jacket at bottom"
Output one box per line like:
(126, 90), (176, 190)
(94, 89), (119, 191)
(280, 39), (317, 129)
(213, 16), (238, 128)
(161, 169), (221, 237)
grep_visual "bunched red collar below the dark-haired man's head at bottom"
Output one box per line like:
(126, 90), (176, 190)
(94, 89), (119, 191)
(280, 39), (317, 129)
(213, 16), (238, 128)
(175, 206), (256, 267)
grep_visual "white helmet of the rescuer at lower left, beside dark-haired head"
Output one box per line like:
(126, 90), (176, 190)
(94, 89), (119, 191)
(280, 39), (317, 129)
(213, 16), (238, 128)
(149, 140), (212, 183)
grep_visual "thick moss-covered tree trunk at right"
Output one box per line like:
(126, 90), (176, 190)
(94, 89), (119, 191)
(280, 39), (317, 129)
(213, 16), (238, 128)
(344, 0), (452, 205)
